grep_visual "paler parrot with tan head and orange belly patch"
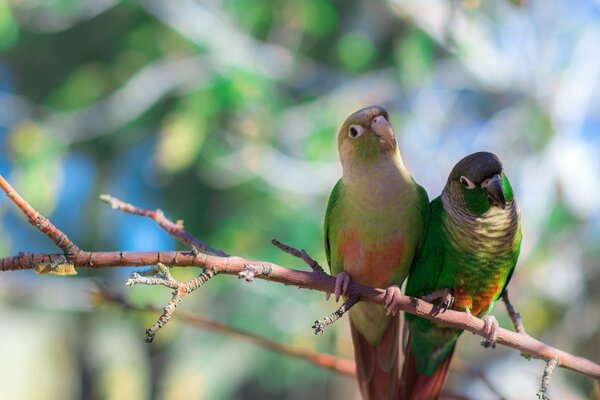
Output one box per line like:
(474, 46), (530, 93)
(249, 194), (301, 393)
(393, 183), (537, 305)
(325, 106), (429, 399)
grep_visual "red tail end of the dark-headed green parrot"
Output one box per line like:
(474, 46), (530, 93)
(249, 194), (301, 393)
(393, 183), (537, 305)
(401, 337), (454, 400)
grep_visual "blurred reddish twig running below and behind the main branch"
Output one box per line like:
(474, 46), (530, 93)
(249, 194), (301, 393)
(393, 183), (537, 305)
(94, 287), (356, 376)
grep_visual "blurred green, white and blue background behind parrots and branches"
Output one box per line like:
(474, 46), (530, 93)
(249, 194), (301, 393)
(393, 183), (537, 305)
(0, 0), (600, 399)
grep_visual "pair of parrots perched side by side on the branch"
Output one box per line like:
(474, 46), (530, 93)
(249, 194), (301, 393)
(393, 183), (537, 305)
(325, 106), (521, 400)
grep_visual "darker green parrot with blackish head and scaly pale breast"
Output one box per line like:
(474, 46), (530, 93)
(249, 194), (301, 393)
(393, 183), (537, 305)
(403, 152), (521, 400)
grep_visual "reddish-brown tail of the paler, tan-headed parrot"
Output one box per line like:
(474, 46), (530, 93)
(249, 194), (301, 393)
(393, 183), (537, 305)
(349, 313), (401, 400)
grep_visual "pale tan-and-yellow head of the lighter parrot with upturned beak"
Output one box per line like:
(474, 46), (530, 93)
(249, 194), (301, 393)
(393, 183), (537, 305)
(338, 106), (398, 164)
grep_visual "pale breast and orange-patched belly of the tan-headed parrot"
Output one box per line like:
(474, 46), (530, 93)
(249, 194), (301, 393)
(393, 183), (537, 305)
(331, 159), (426, 288)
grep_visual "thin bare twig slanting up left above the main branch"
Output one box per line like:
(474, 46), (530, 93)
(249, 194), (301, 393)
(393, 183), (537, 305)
(100, 194), (228, 257)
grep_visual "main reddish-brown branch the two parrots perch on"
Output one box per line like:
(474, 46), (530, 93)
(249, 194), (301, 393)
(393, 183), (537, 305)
(0, 179), (600, 386)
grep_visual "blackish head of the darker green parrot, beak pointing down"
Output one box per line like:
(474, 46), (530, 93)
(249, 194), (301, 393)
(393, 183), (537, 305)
(444, 151), (513, 215)
